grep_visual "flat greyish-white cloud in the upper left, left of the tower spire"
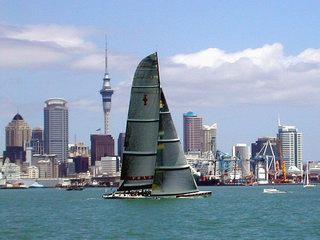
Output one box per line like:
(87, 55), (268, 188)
(0, 25), (96, 68)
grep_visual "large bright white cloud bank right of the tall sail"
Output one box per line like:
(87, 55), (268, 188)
(160, 43), (320, 108)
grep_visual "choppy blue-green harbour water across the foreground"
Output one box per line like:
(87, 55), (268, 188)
(0, 185), (320, 239)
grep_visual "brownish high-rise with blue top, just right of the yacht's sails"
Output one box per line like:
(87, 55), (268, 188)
(183, 112), (202, 153)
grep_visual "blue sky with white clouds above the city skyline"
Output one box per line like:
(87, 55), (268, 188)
(0, 0), (320, 161)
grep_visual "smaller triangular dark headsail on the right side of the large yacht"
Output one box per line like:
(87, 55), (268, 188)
(151, 89), (199, 196)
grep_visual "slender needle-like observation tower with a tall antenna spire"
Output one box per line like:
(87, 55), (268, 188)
(100, 39), (113, 135)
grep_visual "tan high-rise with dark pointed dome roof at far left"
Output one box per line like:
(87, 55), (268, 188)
(4, 113), (31, 162)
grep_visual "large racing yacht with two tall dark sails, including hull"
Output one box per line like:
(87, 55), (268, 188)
(102, 53), (212, 199)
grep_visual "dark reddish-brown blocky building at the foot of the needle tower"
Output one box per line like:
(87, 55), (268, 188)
(90, 134), (114, 166)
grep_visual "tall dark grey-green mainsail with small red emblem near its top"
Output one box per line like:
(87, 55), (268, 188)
(118, 53), (160, 191)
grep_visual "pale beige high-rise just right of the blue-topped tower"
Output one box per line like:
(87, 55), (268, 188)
(202, 123), (217, 156)
